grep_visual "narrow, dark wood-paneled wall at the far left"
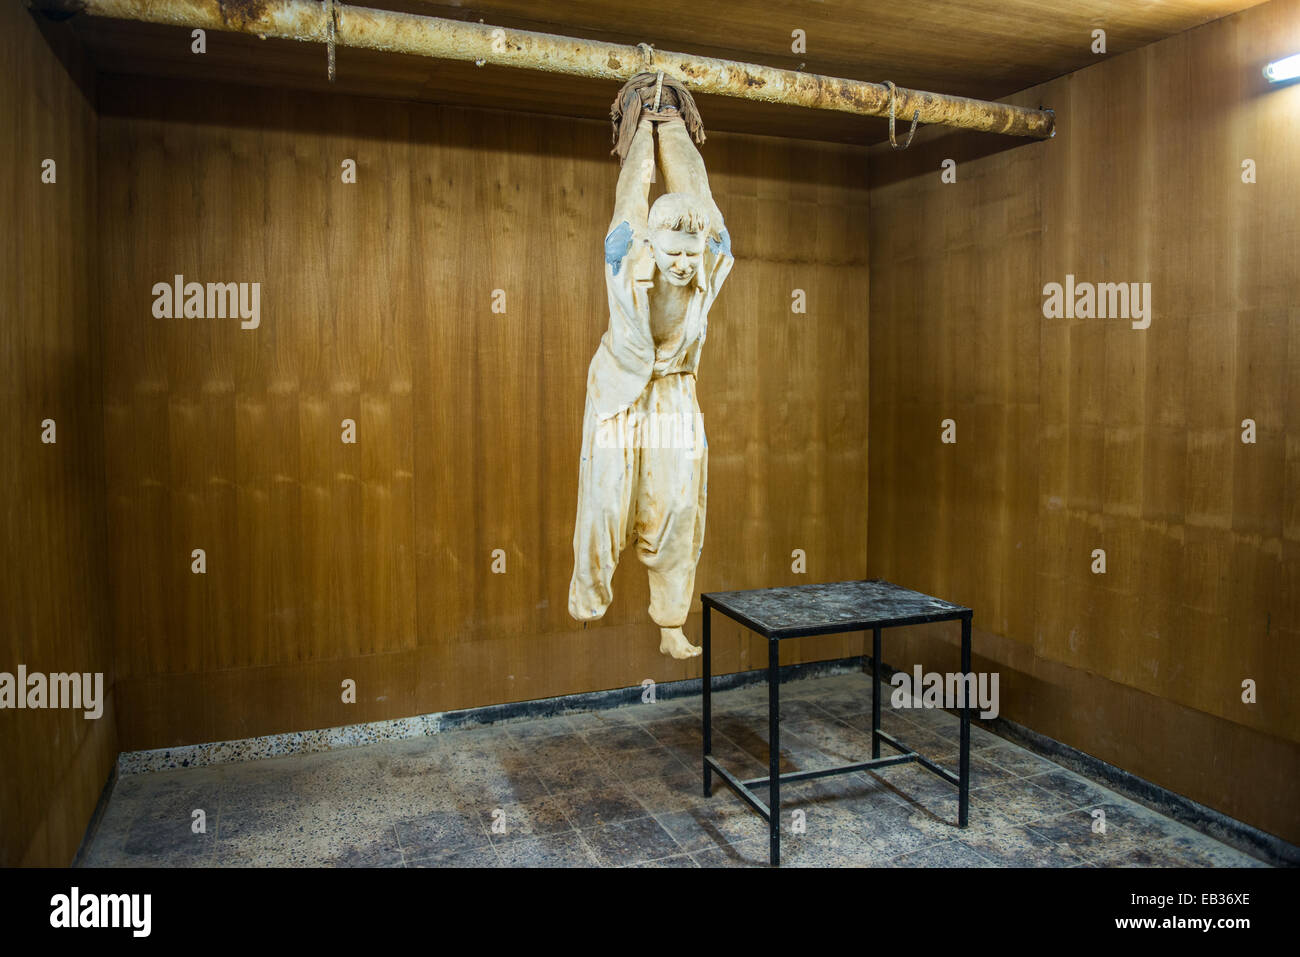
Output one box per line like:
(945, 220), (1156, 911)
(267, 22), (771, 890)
(0, 4), (117, 867)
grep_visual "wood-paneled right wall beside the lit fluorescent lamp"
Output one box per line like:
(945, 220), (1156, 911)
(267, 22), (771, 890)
(868, 0), (1300, 841)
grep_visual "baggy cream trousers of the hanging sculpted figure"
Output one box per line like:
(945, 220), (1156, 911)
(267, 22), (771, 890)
(569, 373), (709, 628)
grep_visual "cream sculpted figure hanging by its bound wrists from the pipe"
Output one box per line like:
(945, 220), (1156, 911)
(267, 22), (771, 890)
(569, 74), (733, 658)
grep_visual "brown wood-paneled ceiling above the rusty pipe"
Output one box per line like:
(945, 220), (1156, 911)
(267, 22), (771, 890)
(69, 0), (1260, 143)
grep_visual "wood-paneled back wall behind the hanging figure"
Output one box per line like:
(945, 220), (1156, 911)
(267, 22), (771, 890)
(99, 77), (868, 750)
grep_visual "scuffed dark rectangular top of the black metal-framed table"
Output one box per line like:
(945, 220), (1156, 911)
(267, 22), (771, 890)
(701, 579), (971, 638)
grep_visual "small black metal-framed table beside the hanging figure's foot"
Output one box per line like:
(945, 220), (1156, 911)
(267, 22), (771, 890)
(699, 579), (974, 867)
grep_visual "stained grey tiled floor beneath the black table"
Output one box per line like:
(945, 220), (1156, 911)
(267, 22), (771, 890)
(83, 675), (1264, 867)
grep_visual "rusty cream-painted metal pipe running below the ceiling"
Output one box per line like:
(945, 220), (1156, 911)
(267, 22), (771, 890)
(29, 0), (1053, 139)
